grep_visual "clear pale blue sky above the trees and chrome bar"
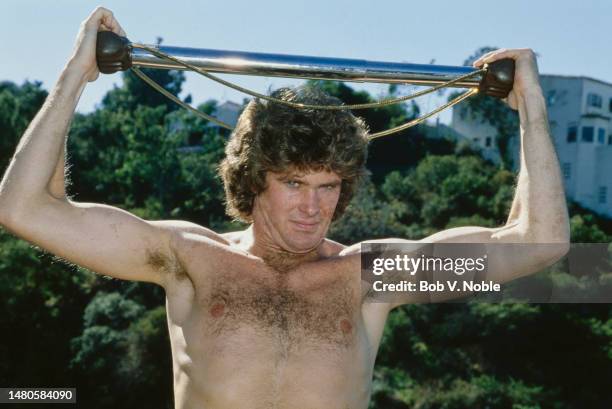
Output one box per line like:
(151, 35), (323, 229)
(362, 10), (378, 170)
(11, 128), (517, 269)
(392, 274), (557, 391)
(0, 0), (612, 122)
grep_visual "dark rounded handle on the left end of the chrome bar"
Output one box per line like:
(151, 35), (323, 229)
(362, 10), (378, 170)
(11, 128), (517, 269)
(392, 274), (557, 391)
(96, 31), (132, 74)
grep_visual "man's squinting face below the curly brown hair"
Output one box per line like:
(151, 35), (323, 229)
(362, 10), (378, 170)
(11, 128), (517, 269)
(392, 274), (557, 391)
(253, 171), (342, 253)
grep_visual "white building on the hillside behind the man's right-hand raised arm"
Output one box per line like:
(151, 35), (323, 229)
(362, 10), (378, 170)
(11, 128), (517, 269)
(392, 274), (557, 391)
(452, 75), (612, 217)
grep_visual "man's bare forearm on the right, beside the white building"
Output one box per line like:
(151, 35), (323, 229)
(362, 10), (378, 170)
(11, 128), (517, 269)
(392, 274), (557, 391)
(516, 89), (569, 243)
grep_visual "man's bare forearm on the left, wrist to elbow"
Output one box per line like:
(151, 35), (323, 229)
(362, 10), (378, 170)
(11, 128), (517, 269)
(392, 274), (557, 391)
(0, 68), (87, 217)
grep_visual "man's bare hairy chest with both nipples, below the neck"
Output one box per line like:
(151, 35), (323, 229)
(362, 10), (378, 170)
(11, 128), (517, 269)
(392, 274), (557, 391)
(168, 239), (382, 351)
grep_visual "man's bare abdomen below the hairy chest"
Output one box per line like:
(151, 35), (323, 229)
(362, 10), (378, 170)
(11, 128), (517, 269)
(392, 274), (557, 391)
(175, 327), (372, 409)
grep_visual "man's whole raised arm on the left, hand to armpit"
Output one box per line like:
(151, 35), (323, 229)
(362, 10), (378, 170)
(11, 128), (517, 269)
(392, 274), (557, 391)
(0, 8), (176, 285)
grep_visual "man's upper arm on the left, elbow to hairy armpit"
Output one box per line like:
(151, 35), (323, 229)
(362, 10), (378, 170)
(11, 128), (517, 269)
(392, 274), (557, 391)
(9, 198), (175, 286)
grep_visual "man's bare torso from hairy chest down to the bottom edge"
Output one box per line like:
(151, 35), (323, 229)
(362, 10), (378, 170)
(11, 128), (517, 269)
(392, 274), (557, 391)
(168, 262), (375, 409)
